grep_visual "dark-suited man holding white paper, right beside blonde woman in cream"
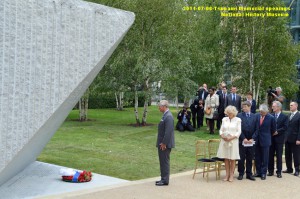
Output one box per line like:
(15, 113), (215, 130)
(237, 101), (257, 181)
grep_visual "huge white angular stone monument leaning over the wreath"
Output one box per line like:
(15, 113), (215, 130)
(0, 0), (134, 185)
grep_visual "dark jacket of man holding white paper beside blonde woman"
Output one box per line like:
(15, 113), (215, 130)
(237, 112), (257, 144)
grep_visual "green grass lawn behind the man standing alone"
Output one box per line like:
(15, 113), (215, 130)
(37, 106), (219, 180)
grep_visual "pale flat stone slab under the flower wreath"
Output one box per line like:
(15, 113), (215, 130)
(0, 161), (128, 199)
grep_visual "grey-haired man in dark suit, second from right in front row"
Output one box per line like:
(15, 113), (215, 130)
(268, 101), (289, 178)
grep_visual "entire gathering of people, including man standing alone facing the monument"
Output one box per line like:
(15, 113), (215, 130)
(155, 84), (300, 186)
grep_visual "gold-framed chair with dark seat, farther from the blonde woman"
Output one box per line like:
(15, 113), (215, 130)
(193, 140), (218, 182)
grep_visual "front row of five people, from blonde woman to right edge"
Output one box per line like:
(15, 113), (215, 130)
(218, 101), (300, 182)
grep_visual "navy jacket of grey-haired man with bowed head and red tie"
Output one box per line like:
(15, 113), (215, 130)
(253, 113), (276, 147)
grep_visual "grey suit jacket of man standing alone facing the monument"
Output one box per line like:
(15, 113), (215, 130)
(156, 110), (175, 148)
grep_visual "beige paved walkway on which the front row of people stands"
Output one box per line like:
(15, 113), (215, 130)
(39, 171), (300, 199)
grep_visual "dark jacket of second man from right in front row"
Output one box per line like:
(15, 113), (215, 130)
(272, 112), (289, 144)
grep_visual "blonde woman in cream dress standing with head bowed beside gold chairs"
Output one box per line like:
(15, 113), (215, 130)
(217, 106), (241, 182)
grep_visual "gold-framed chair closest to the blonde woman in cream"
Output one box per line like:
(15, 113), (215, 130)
(208, 139), (224, 179)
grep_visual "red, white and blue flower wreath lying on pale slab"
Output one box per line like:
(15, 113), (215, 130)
(60, 169), (92, 182)
